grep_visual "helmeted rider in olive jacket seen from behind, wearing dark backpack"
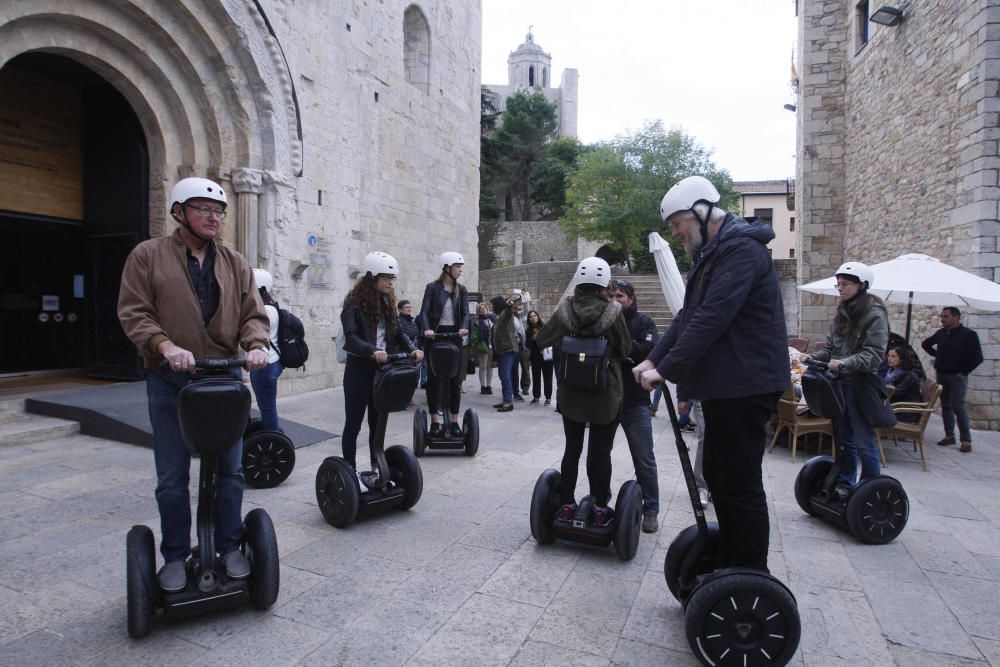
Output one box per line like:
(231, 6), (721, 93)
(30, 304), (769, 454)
(535, 257), (632, 526)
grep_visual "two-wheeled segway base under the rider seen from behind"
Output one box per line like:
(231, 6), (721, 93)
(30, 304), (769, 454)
(530, 468), (642, 560)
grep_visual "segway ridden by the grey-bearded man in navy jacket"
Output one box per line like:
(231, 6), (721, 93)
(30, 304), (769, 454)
(663, 390), (801, 667)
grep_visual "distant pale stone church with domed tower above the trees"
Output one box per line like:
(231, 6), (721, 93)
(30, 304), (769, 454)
(483, 30), (580, 137)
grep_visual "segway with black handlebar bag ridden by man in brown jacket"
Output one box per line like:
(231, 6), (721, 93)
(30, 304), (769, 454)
(125, 359), (279, 637)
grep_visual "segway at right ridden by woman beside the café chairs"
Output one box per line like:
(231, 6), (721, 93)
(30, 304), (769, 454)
(795, 360), (910, 544)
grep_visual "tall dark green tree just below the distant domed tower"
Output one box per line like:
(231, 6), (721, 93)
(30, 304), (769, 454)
(493, 90), (558, 220)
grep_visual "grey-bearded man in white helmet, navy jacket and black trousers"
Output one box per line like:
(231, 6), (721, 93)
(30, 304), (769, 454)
(633, 176), (791, 572)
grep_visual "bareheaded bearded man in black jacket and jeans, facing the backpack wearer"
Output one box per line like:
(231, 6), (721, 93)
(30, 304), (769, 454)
(608, 278), (660, 533)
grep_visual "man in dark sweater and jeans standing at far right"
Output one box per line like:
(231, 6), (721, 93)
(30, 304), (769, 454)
(922, 306), (983, 454)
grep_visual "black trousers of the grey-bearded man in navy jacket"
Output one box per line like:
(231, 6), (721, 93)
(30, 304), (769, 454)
(701, 394), (780, 572)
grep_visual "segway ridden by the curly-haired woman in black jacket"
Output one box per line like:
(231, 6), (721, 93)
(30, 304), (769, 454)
(316, 352), (424, 528)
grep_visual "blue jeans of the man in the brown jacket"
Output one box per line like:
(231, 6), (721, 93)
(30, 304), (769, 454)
(146, 369), (244, 563)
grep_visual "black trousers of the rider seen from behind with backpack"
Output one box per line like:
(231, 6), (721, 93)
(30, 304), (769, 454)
(559, 417), (618, 507)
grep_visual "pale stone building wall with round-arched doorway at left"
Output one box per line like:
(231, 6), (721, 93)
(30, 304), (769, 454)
(0, 0), (482, 393)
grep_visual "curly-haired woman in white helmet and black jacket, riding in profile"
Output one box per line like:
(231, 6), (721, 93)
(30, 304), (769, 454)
(340, 252), (423, 491)
